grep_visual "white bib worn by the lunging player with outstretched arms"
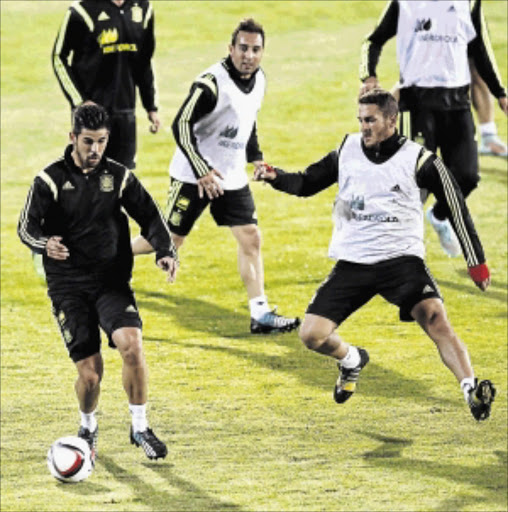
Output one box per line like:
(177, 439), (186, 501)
(329, 133), (425, 264)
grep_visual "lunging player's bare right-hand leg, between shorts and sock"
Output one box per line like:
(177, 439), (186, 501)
(411, 299), (474, 383)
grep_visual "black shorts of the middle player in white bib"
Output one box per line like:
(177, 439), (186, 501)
(165, 178), (257, 236)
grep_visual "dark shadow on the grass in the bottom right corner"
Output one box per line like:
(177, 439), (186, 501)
(358, 431), (507, 512)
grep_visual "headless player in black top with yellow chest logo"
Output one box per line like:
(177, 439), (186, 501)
(52, 0), (160, 169)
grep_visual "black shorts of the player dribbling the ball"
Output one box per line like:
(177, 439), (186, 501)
(49, 284), (142, 362)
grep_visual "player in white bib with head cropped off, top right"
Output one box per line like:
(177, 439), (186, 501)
(360, 0), (508, 257)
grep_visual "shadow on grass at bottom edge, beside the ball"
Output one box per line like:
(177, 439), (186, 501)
(92, 455), (241, 512)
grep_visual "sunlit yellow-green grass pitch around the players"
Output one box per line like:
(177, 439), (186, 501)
(0, 0), (508, 512)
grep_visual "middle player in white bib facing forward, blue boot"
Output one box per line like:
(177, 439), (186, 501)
(133, 19), (300, 334)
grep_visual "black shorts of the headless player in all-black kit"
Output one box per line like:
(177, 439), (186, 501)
(105, 113), (136, 169)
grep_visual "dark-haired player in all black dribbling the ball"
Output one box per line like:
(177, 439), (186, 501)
(18, 102), (177, 459)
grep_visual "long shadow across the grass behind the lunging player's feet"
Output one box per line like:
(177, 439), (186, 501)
(136, 290), (461, 406)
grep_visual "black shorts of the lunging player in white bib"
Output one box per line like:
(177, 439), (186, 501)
(307, 256), (442, 325)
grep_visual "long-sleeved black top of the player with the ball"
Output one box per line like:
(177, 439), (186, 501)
(18, 146), (176, 289)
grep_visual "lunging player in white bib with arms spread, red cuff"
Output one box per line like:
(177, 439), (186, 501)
(254, 89), (496, 421)
